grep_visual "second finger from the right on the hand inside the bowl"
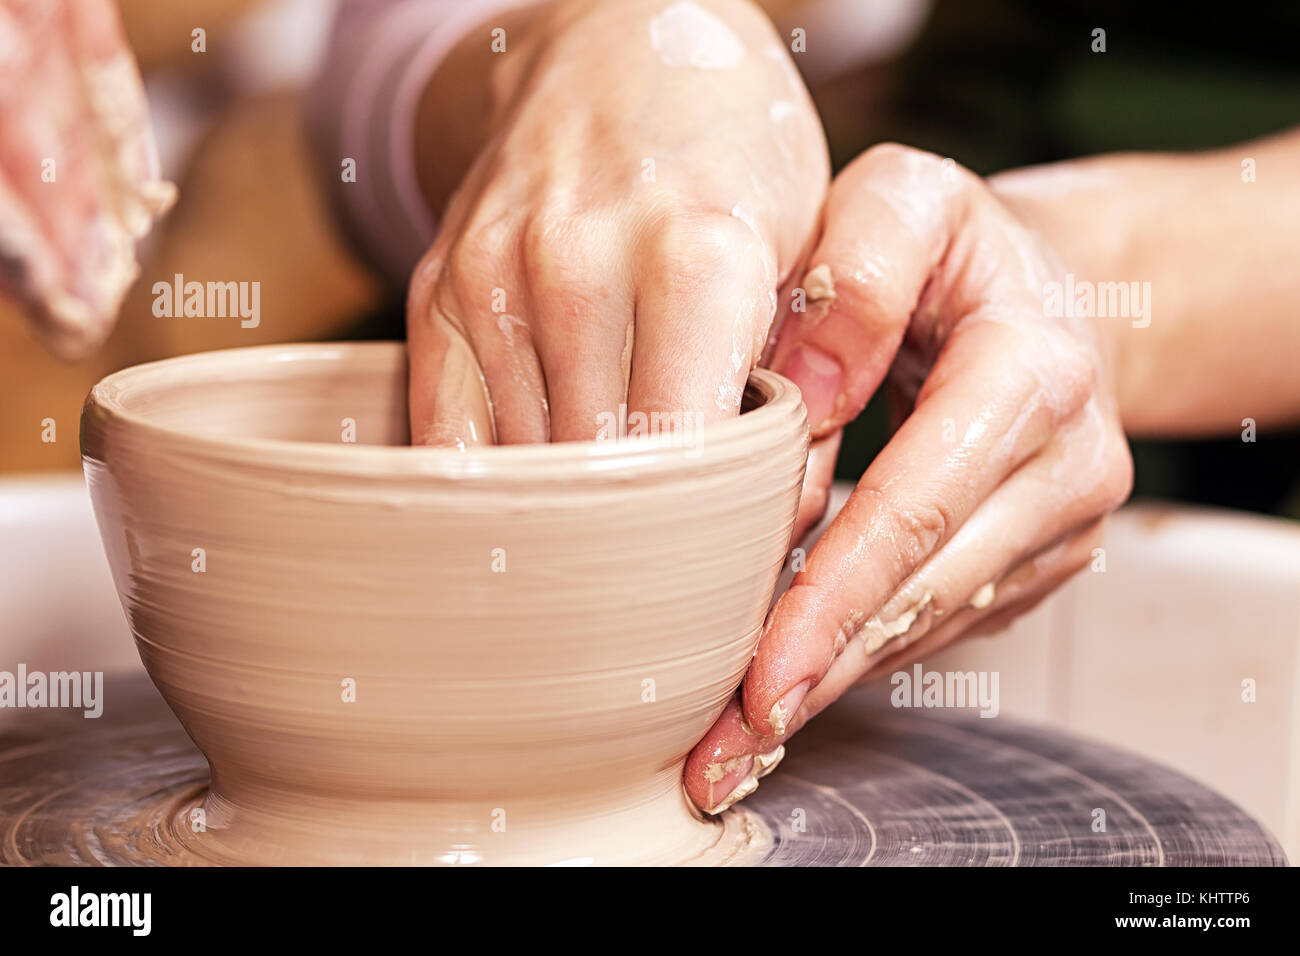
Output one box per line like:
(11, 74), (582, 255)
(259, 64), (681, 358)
(524, 219), (634, 441)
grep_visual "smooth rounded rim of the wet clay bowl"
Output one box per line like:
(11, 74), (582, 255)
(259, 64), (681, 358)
(82, 341), (809, 484)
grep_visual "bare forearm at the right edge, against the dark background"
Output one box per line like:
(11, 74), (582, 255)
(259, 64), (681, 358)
(993, 131), (1300, 436)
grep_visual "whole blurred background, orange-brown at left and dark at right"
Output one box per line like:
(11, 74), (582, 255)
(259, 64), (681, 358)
(0, 0), (1300, 518)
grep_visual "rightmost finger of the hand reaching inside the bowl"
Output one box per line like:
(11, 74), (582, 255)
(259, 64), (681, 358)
(628, 216), (776, 425)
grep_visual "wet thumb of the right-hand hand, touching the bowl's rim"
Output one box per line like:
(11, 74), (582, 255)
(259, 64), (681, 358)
(772, 146), (969, 437)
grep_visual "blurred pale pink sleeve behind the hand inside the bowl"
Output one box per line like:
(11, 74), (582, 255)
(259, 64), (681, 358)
(309, 0), (529, 285)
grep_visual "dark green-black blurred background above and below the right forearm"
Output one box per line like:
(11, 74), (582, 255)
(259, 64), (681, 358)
(818, 0), (1300, 516)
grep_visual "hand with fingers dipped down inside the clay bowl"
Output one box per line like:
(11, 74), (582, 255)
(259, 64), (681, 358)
(408, 0), (828, 444)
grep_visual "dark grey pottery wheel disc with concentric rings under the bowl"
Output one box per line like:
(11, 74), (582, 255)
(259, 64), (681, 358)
(0, 676), (1286, 866)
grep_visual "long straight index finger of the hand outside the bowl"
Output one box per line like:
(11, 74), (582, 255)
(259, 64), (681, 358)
(744, 310), (1092, 732)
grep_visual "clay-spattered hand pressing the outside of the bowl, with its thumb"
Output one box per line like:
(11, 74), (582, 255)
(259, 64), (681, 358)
(685, 146), (1131, 809)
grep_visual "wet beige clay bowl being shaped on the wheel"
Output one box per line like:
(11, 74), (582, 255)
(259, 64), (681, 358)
(82, 343), (807, 864)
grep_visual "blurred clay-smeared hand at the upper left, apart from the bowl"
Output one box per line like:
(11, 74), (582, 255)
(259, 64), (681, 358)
(0, 0), (176, 356)
